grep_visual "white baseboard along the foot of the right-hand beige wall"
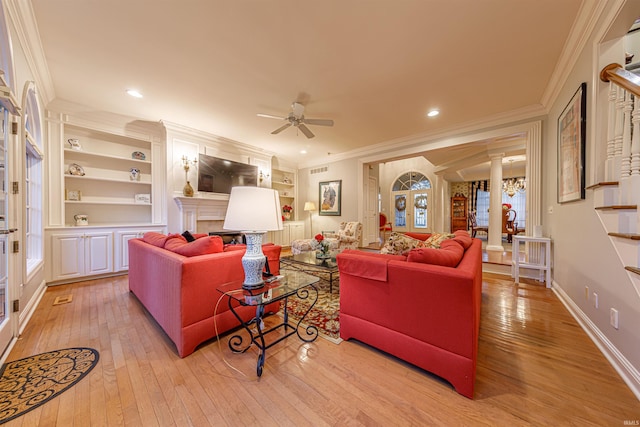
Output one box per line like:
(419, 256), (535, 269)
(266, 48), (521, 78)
(552, 281), (640, 400)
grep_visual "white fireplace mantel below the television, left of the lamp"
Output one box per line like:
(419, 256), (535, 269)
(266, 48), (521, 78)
(173, 194), (229, 232)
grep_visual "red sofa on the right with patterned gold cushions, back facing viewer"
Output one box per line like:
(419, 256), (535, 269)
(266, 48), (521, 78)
(337, 232), (482, 399)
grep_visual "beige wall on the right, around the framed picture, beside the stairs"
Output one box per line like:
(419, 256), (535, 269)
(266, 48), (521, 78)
(542, 2), (640, 389)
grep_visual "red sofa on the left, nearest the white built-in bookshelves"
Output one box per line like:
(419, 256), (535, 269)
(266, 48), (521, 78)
(129, 233), (281, 357)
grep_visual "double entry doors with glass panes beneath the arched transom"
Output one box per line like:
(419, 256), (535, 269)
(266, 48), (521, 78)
(391, 189), (432, 233)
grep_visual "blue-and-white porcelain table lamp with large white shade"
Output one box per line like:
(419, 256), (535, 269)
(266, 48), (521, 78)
(222, 187), (282, 289)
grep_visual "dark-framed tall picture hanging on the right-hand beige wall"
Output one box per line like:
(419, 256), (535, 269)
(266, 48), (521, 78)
(558, 83), (587, 203)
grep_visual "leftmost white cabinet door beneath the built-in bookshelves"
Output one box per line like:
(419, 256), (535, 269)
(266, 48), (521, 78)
(51, 234), (84, 280)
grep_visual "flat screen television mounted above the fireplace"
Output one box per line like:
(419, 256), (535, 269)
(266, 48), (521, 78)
(198, 154), (258, 194)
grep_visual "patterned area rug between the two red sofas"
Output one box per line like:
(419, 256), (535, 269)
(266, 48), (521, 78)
(280, 261), (342, 344)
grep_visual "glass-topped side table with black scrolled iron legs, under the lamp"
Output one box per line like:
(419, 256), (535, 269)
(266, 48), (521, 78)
(218, 271), (320, 376)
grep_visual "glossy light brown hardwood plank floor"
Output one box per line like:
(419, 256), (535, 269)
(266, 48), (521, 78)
(6, 274), (640, 426)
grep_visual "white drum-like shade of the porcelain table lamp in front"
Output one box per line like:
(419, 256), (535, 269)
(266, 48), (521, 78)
(222, 187), (282, 231)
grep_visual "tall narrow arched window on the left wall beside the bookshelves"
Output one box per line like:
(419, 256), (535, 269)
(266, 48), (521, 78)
(24, 88), (44, 275)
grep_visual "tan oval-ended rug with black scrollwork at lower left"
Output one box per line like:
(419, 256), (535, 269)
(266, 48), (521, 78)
(0, 347), (100, 424)
